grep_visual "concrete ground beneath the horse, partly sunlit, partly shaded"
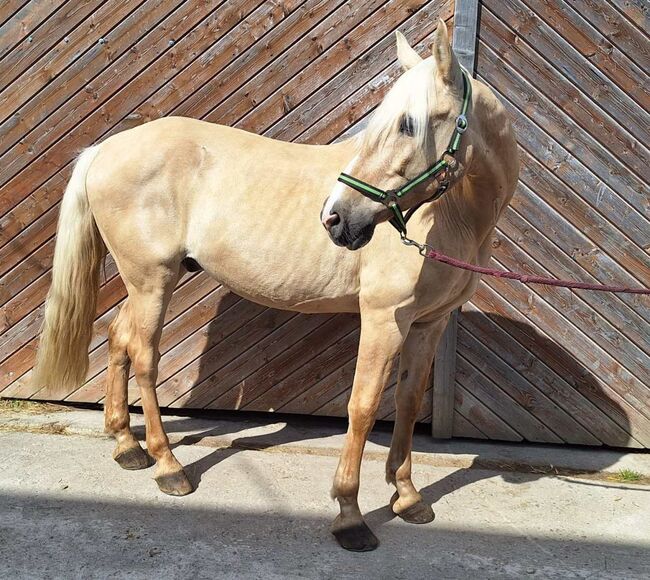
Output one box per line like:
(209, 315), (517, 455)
(0, 411), (650, 579)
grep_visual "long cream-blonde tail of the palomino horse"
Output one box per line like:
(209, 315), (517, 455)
(32, 147), (106, 399)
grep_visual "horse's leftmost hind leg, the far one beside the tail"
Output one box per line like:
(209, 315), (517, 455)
(104, 300), (152, 469)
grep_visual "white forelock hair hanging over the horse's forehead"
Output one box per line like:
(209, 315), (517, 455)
(361, 58), (436, 149)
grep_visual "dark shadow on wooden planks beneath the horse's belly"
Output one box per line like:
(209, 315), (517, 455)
(174, 278), (368, 417)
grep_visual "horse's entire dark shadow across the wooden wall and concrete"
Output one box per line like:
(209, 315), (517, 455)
(149, 300), (638, 502)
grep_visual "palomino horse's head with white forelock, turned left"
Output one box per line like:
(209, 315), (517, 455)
(321, 20), (463, 250)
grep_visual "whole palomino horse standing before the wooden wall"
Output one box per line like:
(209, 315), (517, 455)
(34, 21), (518, 550)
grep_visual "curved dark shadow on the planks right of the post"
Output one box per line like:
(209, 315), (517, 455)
(456, 307), (632, 447)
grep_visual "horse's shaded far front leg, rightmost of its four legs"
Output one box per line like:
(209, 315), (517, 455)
(386, 317), (447, 524)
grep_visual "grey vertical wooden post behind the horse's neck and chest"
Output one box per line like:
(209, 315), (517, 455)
(431, 0), (479, 439)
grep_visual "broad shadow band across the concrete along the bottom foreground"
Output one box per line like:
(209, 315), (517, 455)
(0, 491), (648, 578)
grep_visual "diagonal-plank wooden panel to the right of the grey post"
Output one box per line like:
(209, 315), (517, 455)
(446, 0), (650, 447)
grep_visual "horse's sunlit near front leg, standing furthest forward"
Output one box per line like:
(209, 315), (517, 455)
(331, 310), (406, 552)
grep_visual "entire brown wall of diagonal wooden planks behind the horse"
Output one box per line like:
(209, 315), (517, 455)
(0, 0), (650, 447)
